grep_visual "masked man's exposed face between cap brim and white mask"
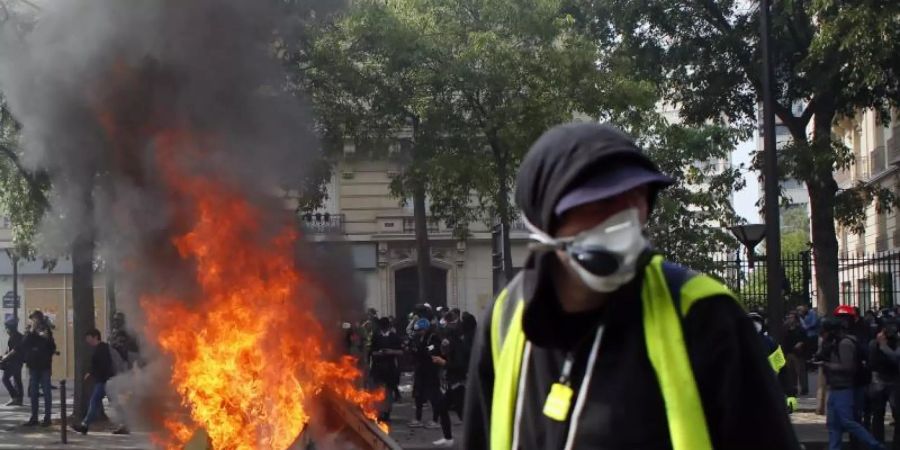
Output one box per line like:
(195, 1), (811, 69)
(555, 186), (650, 237)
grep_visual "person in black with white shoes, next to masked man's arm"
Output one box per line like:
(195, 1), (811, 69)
(431, 311), (473, 447)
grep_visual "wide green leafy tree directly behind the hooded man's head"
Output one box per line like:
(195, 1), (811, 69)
(307, 0), (655, 284)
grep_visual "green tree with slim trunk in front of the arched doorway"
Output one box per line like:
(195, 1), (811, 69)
(294, 1), (445, 301)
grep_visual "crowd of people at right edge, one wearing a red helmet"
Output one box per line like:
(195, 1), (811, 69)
(750, 305), (900, 450)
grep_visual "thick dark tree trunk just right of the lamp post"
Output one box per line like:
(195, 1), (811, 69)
(807, 112), (839, 314)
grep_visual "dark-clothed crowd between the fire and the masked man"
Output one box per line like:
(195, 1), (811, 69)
(344, 303), (476, 447)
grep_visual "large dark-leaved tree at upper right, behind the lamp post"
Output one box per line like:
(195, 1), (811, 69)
(570, 0), (900, 310)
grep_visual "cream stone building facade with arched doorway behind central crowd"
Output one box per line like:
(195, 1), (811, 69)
(288, 158), (528, 316)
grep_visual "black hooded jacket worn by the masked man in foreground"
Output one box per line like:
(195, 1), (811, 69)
(462, 124), (799, 450)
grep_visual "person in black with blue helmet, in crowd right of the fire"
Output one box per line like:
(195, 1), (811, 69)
(409, 319), (441, 428)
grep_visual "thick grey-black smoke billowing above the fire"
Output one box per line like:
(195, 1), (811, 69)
(0, 0), (359, 444)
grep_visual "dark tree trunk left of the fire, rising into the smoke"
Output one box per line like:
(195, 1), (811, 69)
(71, 198), (96, 420)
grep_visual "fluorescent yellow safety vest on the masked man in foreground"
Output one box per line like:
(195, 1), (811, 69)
(490, 256), (735, 450)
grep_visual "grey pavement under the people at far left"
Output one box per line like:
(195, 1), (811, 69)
(0, 380), (154, 450)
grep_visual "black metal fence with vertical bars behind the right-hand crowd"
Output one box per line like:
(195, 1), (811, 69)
(711, 251), (900, 311)
